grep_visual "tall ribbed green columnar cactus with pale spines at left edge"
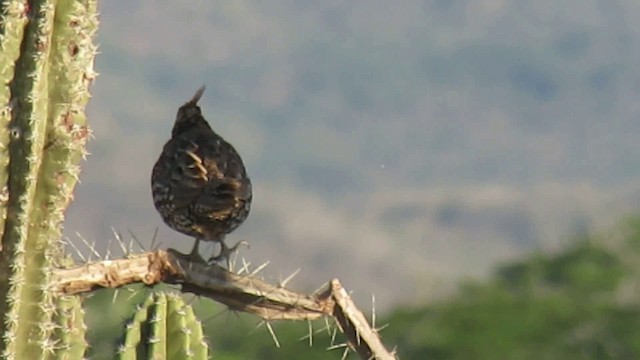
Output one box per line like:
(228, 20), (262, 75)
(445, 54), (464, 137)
(0, 0), (97, 359)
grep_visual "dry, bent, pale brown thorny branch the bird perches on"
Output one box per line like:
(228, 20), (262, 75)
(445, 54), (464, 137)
(52, 250), (396, 360)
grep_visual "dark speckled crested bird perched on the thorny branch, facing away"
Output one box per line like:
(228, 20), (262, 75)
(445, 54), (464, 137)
(151, 86), (253, 267)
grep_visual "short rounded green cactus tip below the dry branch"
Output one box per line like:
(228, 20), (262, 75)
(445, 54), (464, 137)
(119, 293), (208, 360)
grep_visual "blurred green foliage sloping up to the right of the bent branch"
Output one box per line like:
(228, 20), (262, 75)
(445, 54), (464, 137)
(383, 220), (640, 359)
